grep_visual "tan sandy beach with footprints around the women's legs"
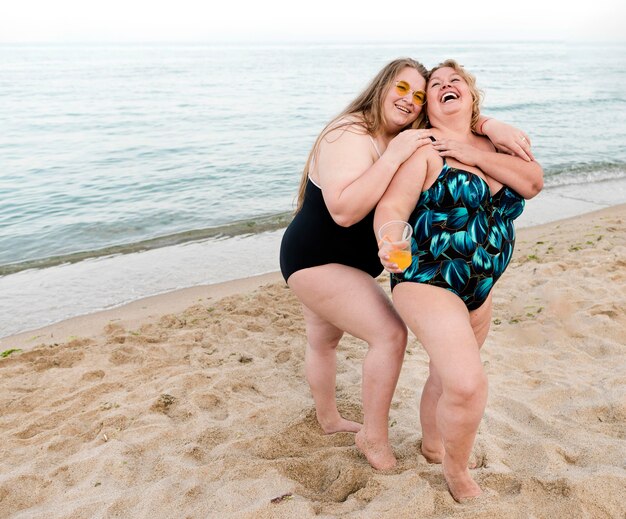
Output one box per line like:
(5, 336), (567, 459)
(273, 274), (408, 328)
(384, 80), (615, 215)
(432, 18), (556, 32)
(0, 205), (626, 519)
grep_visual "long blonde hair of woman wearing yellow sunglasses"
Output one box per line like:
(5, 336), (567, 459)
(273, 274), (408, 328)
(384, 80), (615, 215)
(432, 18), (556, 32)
(296, 58), (428, 213)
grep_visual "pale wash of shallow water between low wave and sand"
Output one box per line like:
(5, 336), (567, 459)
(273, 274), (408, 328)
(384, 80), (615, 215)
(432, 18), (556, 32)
(0, 178), (626, 344)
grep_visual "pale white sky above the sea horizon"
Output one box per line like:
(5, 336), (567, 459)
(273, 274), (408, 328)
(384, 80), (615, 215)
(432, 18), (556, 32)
(0, 0), (626, 43)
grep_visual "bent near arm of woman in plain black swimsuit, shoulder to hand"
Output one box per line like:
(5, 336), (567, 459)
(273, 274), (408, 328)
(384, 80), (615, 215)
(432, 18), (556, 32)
(317, 124), (431, 227)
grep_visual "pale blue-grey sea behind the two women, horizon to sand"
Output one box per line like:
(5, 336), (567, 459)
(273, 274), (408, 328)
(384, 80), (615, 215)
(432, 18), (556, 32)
(0, 42), (626, 337)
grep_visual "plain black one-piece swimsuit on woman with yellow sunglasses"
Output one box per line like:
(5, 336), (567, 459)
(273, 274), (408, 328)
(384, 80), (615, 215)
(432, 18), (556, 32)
(280, 179), (383, 281)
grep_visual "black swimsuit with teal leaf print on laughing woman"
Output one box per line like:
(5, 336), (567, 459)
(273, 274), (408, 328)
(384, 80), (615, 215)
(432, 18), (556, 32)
(391, 159), (525, 310)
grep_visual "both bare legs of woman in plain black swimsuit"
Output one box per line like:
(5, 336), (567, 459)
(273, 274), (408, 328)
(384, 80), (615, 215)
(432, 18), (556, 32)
(289, 264), (406, 470)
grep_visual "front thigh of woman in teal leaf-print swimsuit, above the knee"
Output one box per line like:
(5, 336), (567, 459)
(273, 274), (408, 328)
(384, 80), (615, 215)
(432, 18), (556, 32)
(393, 283), (482, 384)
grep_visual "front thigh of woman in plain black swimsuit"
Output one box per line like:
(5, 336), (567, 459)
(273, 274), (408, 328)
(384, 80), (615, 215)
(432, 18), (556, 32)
(289, 263), (405, 342)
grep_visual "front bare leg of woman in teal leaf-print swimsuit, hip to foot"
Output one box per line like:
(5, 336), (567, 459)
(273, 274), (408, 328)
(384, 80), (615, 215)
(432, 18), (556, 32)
(394, 283), (487, 501)
